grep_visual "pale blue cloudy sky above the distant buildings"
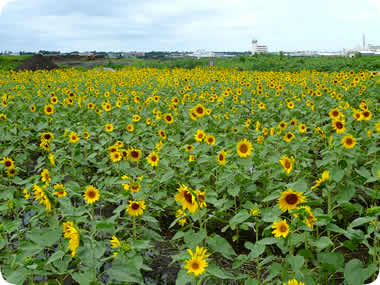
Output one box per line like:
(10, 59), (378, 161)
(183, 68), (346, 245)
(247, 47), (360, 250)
(0, 0), (380, 52)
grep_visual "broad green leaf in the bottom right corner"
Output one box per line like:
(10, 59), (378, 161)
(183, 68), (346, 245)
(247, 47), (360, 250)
(344, 259), (377, 285)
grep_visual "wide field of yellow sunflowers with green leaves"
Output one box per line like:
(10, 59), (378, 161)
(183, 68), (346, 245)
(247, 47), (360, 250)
(0, 67), (380, 285)
